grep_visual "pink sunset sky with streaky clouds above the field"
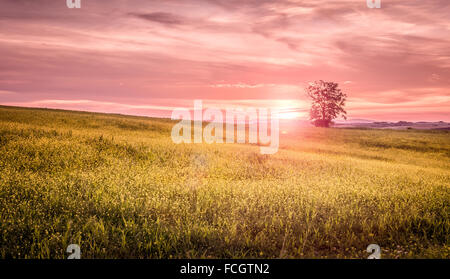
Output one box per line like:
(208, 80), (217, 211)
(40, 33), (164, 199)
(0, 0), (450, 121)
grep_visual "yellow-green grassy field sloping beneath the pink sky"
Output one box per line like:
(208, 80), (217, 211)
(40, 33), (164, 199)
(0, 107), (450, 258)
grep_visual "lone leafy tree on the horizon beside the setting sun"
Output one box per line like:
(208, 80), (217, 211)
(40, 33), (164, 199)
(306, 80), (347, 127)
